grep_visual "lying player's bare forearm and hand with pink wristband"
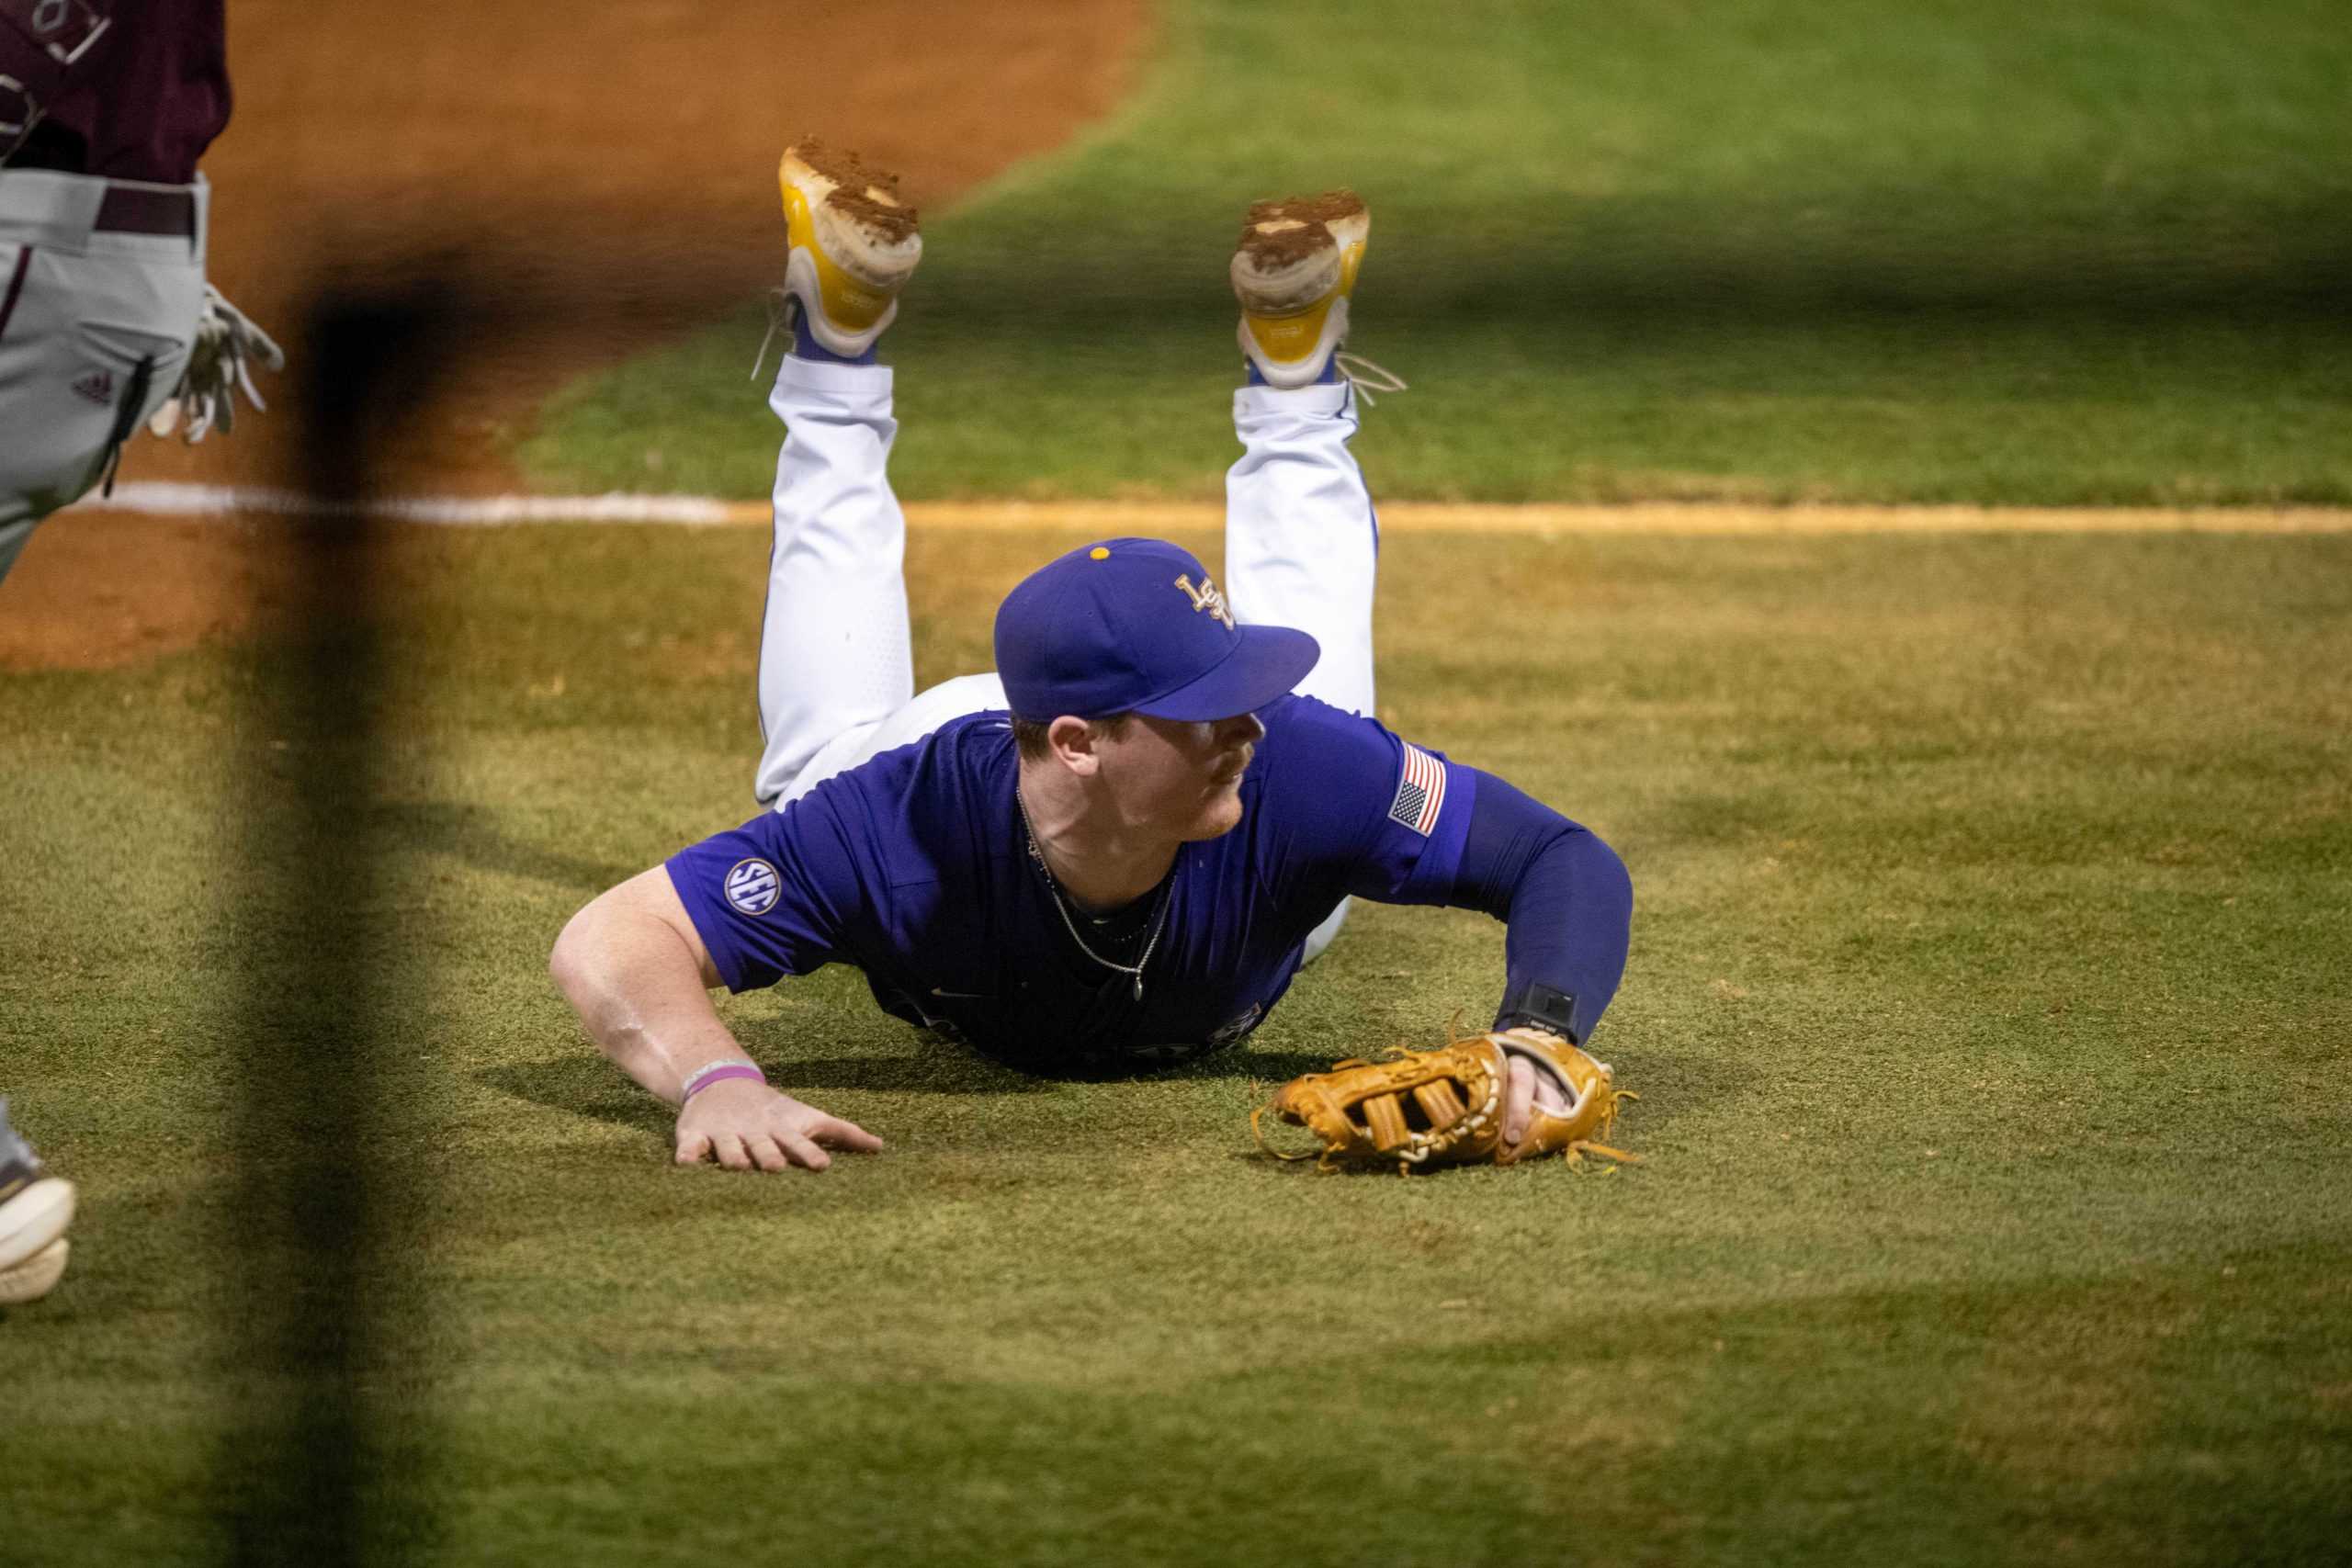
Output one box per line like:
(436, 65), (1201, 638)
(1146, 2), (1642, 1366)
(548, 865), (882, 1170)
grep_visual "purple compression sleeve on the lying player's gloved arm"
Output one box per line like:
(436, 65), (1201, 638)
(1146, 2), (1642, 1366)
(1446, 769), (1633, 1043)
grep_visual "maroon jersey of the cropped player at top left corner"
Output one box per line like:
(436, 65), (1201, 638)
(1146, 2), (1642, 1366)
(0, 0), (228, 186)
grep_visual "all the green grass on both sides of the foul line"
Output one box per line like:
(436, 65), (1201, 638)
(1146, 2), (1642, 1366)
(0, 0), (2352, 1568)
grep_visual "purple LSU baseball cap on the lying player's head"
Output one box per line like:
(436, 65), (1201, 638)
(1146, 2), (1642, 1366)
(997, 538), (1322, 724)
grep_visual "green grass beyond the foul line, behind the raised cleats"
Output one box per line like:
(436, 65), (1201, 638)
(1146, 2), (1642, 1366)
(520, 0), (2352, 503)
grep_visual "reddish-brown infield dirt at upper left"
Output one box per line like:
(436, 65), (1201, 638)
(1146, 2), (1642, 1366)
(0, 0), (1150, 668)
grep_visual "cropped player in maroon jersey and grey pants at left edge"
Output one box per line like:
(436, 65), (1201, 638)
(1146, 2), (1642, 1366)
(0, 0), (285, 579)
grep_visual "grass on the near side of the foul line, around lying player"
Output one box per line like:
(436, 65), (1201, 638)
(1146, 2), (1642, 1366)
(0, 522), (2352, 1568)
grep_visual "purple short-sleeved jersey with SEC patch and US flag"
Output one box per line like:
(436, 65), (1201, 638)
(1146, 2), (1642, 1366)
(668, 696), (1475, 1067)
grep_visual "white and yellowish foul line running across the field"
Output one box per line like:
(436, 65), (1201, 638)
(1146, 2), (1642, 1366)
(80, 479), (2352, 536)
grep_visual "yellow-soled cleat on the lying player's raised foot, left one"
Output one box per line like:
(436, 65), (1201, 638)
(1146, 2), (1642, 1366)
(776, 136), (922, 360)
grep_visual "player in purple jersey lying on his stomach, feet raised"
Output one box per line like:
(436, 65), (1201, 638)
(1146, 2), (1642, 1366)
(550, 143), (1633, 1170)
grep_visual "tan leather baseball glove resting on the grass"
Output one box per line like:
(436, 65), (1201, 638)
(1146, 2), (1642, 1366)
(1249, 1027), (1642, 1173)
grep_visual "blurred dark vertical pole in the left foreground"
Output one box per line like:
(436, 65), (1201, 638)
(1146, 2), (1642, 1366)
(211, 296), (449, 1568)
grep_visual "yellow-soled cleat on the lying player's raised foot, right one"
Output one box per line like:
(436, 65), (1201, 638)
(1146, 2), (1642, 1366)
(1232, 190), (1371, 388)
